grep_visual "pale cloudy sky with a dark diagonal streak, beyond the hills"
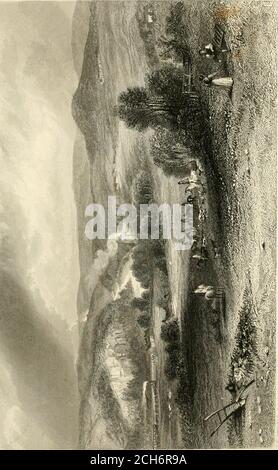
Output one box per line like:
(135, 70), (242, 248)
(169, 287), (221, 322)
(0, 2), (80, 449)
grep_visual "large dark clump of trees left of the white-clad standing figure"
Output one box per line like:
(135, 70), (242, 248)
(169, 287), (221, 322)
(117, 2), (203, 176)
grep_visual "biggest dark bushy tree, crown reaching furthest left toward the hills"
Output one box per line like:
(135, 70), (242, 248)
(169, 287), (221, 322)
(117, 64), (187, 131)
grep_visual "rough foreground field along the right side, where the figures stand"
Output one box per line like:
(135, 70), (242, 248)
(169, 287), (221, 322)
(148, 1), (276, 448)
